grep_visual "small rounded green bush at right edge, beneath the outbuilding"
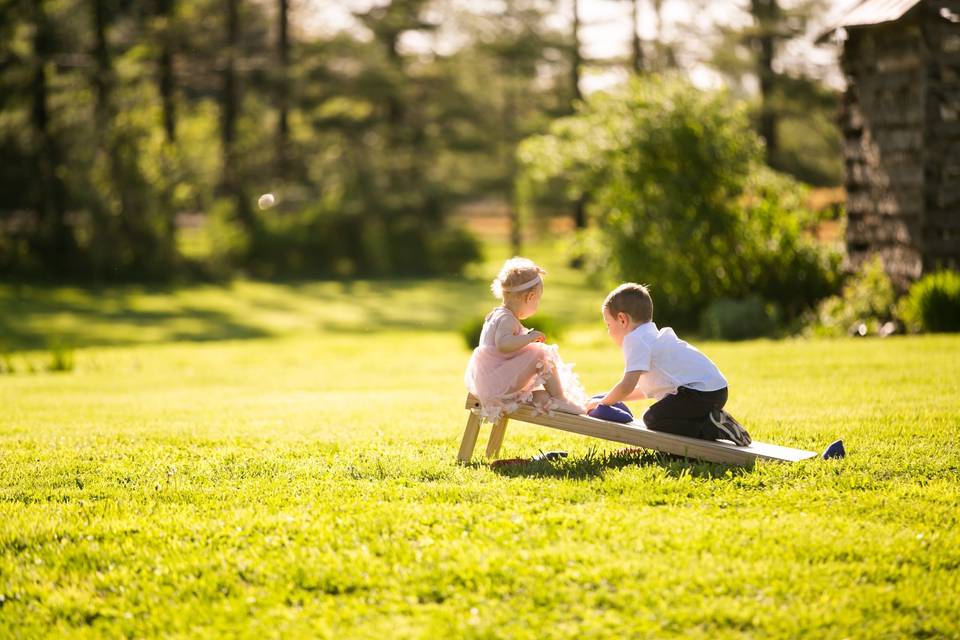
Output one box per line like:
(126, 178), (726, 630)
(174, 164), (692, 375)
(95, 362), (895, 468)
(897, 271), (960, 332)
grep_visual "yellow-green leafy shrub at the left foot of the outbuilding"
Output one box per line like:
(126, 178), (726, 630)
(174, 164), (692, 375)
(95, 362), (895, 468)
(806, 257), (896, 337)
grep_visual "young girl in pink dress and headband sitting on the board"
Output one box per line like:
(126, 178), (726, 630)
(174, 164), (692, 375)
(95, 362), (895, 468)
(464, 258), (587, 421)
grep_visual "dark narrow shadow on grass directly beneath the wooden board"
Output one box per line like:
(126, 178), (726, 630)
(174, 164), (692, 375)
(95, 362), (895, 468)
(491, 449), (753, 480)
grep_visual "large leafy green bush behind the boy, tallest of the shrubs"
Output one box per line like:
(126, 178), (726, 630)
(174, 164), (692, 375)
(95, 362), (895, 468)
(520, 77), (840, 327)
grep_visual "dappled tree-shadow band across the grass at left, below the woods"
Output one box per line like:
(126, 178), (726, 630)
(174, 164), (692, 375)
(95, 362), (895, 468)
(0, 278), (492, 352)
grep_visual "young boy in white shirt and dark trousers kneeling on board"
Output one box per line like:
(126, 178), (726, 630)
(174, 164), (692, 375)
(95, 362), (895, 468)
(587, 282), (751, 447)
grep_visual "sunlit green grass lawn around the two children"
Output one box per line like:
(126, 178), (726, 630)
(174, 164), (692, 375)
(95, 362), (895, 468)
(0, 252), (960, 638)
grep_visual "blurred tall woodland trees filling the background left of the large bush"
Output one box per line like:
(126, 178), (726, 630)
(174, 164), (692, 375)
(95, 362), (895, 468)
(0, 0), (840, 280)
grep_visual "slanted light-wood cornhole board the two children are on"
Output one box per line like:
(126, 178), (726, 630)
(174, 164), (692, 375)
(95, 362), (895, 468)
(457, 394), (817, 466)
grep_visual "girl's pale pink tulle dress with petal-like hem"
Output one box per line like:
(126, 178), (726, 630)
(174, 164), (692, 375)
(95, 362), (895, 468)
(464, 307), (587, 422)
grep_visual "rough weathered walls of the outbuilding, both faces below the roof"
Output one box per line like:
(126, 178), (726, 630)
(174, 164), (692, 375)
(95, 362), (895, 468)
(841, 2), (960, 289)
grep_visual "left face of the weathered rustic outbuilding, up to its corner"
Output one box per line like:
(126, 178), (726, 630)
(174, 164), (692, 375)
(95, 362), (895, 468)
(841, 14), (927, 287)
